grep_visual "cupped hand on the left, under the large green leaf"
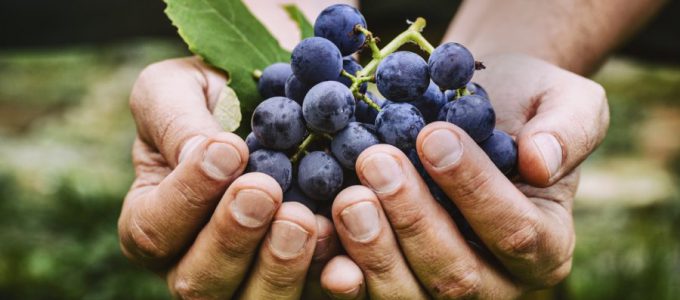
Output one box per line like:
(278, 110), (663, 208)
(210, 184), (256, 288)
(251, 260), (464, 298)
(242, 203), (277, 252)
(118, 58), (338, 299)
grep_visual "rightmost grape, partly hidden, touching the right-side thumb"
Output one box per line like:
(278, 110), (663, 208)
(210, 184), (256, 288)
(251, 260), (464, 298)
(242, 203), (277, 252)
(479, 129), (517, 176)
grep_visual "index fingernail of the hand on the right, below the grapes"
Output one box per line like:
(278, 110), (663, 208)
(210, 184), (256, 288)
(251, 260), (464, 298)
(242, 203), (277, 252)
(422, 129), (463, 168)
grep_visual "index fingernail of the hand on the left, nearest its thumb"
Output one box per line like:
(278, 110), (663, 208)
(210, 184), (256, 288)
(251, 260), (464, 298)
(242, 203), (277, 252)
(203, 142), (241, 180)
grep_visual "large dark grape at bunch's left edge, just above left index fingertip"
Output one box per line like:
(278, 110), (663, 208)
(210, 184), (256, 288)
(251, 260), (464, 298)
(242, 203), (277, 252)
(250, 96), (306, 150)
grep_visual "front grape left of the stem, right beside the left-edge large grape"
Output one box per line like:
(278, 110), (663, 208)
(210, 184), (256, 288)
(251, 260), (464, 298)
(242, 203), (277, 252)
(302, 81), (355, 133)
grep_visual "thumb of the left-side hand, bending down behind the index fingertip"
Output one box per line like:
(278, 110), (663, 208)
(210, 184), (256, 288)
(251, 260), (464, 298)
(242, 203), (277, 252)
(130, 58), (226, 168)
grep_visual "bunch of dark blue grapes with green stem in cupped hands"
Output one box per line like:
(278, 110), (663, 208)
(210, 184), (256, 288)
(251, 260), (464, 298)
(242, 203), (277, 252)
(246, 4), (517, 220)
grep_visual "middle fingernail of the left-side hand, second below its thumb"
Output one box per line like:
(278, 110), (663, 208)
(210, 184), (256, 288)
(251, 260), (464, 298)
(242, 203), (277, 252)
(231, 189), (276, 228)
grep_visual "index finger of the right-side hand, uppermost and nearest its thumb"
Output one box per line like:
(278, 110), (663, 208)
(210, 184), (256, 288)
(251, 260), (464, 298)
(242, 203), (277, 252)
(417, 122), (574, 285)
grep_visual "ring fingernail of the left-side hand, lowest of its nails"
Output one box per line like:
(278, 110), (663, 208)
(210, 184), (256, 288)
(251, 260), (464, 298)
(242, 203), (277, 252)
(269, 220), (309, 259)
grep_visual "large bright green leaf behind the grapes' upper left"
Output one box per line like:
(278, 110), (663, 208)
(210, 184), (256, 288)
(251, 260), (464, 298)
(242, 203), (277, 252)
(165, 0), (290, 131)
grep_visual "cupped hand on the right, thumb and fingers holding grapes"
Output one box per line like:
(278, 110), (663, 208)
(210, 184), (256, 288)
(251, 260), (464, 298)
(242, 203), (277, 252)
(322, 55), (609, 299)
